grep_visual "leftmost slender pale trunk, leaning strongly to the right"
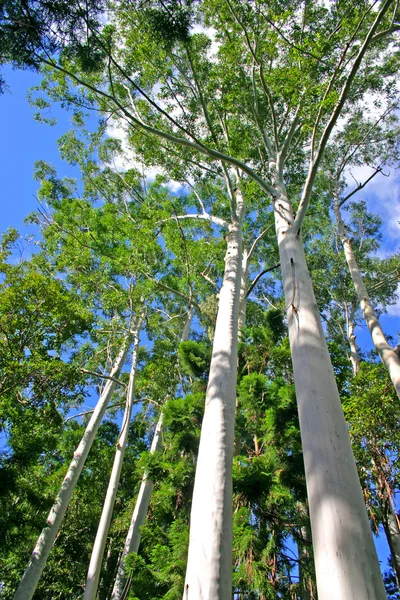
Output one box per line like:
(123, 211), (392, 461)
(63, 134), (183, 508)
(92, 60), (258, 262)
(14, 338), (130, 600)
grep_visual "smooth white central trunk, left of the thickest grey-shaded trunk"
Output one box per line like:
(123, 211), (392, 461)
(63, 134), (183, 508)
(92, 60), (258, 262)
(183, 191), (244, 600)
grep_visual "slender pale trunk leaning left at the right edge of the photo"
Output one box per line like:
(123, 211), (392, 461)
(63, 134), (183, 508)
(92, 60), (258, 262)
(335, 193), (400, 399)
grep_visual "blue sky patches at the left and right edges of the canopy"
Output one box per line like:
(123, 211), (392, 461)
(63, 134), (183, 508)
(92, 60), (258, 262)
(0, 68), (400, 567)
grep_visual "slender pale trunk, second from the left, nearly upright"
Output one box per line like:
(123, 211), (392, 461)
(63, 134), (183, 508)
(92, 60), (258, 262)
(84, 317), (143, 600)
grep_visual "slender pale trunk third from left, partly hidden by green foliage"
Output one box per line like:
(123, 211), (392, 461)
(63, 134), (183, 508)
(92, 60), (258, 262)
(111, 306), (194, 600)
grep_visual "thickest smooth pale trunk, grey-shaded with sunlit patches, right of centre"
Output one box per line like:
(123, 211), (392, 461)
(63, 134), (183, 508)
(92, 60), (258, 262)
(272, 165), (386, 600)
